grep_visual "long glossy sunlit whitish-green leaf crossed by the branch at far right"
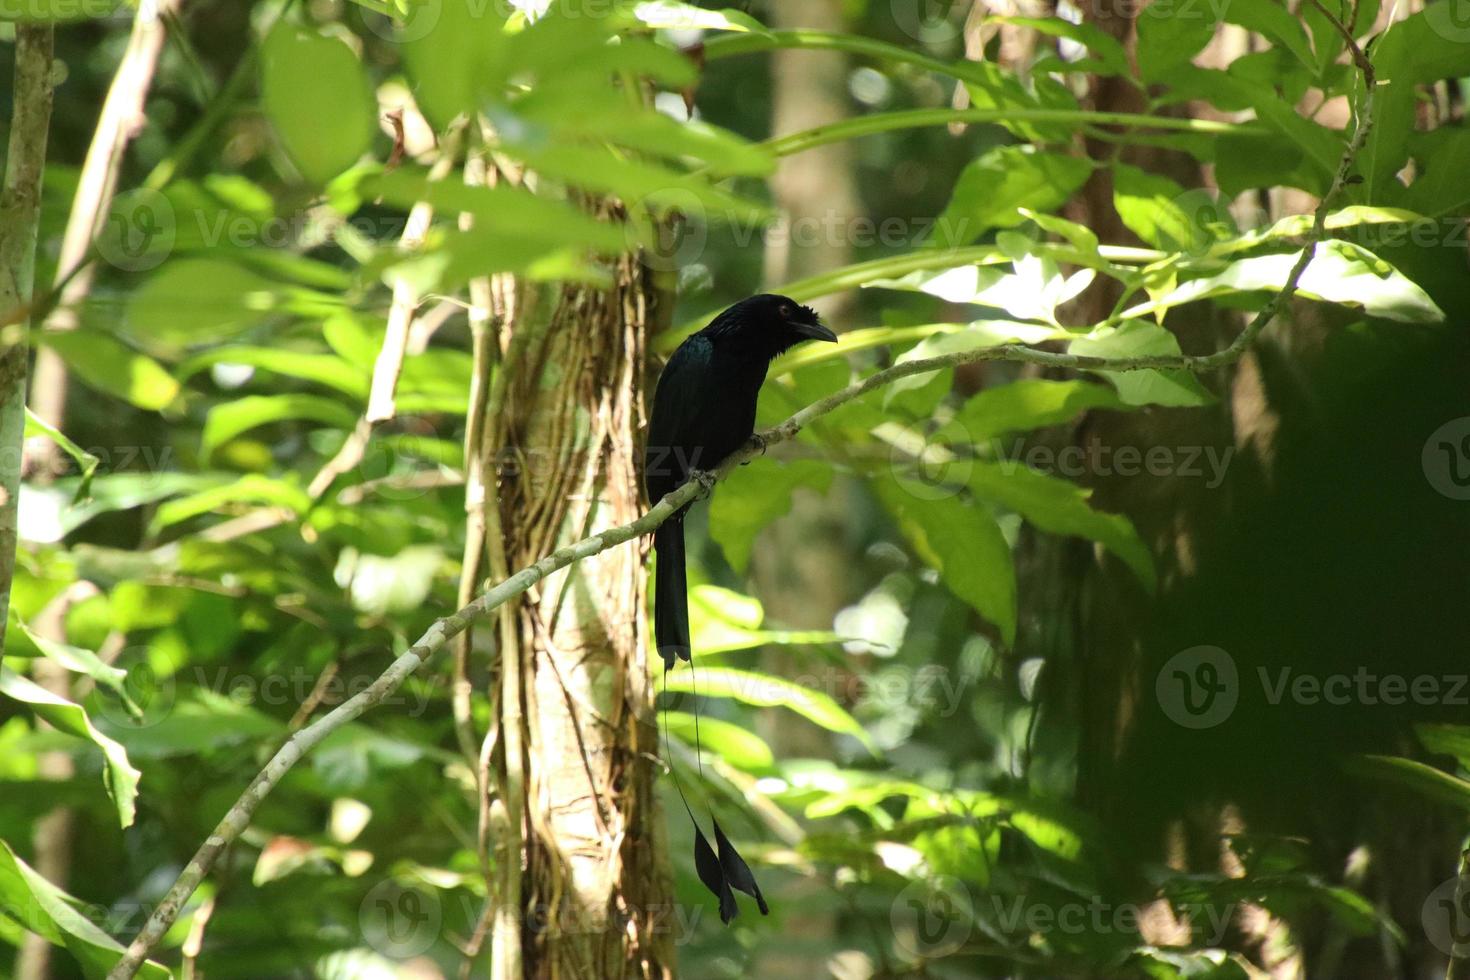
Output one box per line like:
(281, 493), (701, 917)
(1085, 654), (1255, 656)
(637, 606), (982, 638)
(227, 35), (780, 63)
(1123, 239), (1445, 326)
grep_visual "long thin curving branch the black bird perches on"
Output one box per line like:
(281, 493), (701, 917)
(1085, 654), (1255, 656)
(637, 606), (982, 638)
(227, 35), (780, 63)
(107, 34), (1374, 980)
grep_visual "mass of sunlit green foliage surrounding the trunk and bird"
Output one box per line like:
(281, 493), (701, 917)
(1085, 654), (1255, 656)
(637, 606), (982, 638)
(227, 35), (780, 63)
(0, 0), (1470, 977)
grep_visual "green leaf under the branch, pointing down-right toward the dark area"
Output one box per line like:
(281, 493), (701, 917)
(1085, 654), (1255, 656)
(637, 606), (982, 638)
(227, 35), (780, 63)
(967, 460), (1158, 592)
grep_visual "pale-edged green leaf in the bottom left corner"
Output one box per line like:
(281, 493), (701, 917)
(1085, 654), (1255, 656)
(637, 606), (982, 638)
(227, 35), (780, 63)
(0, 840), (171, 980)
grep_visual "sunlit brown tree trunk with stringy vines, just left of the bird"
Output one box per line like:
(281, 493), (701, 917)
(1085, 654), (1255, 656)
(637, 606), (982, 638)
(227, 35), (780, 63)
(495, 226), (676, 979)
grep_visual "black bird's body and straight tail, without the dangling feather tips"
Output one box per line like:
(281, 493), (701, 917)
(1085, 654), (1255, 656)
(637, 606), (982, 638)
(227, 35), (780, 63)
(644, 292), (836, 670)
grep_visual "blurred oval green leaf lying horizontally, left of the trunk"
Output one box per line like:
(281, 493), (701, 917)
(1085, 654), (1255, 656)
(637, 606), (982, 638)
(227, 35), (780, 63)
(123, 259), (279, 350)
